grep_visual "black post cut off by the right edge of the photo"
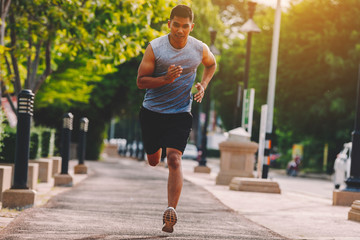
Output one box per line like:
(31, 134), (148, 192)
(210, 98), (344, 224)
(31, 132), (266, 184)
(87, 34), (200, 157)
(345, 65), (360, 192)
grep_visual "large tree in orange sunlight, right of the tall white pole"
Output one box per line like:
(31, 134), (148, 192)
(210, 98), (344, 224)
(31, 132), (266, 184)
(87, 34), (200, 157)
(276, 0), (360, 169)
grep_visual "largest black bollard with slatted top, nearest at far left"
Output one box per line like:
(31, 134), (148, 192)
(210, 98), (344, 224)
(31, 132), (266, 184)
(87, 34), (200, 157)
(12, 89), (35, 189)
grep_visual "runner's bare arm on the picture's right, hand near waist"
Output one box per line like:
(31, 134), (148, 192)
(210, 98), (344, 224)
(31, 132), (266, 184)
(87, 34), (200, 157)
(194, 44), (216, 103)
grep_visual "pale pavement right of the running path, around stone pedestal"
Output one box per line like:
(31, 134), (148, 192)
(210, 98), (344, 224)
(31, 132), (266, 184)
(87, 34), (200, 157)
(183, 159), (360, 240)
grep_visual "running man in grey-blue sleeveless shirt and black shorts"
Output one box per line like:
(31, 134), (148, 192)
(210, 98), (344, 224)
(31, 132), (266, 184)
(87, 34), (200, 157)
(137, 5), (216, 233)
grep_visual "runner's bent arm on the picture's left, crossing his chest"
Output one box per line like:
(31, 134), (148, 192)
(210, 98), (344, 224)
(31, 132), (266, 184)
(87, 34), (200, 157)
(137, 44), (182, 89)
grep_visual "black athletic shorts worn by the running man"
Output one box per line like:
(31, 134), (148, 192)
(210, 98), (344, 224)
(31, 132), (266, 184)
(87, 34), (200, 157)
(139, 107), (192, 154)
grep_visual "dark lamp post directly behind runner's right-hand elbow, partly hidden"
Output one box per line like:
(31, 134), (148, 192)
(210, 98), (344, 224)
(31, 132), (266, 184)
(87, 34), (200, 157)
(194, 29), (220, 173)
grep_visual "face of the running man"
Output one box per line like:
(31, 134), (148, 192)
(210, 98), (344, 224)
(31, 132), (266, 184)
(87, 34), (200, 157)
(168, 16), (194, 44)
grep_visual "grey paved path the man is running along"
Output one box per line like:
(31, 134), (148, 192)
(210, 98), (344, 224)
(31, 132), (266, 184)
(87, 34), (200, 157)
(0, 158), (286, 240)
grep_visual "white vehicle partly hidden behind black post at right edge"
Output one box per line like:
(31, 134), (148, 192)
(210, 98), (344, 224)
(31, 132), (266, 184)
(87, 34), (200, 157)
(334, 142), (352, 189)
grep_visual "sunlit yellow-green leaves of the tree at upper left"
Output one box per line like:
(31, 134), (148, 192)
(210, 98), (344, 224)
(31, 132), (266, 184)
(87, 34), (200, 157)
(2, 0), (179, 93)
